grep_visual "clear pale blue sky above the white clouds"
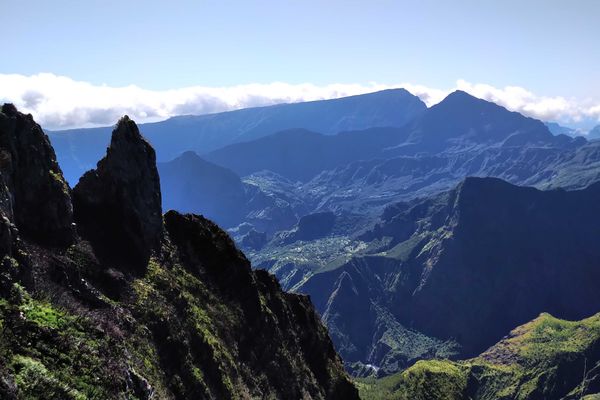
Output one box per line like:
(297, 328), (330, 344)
(0, 0), (600, 128)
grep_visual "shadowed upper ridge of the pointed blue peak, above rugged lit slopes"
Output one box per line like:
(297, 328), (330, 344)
(206, 91), (585, 181)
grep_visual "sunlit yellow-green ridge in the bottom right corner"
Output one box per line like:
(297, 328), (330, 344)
(359, 314), (600, 400)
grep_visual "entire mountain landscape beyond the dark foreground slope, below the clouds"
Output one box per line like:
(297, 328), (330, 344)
(32, 91), (600, 399)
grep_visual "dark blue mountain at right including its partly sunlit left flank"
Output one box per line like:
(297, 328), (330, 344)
(295, 178), (600, 372)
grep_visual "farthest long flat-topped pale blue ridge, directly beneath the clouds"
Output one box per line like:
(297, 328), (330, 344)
(49, 89), (426, 184)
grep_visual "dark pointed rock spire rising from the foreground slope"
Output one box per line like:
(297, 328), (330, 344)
(73, 116), (162, 271)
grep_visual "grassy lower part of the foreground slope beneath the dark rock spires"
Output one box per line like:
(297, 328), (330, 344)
(0, 231), (354, 400)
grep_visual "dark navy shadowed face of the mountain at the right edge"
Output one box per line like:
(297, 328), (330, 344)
(407, 178), (600, 356)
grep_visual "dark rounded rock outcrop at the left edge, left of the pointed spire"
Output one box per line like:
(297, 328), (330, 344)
(0, 104), (75, 246)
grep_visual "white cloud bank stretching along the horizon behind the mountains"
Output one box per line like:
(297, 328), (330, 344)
(0, 73), (600, 129)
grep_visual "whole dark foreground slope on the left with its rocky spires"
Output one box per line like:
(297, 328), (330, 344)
(0, 105), (357, 399)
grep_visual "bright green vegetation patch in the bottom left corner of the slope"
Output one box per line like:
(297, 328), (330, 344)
(0, 284), (122, 399)
